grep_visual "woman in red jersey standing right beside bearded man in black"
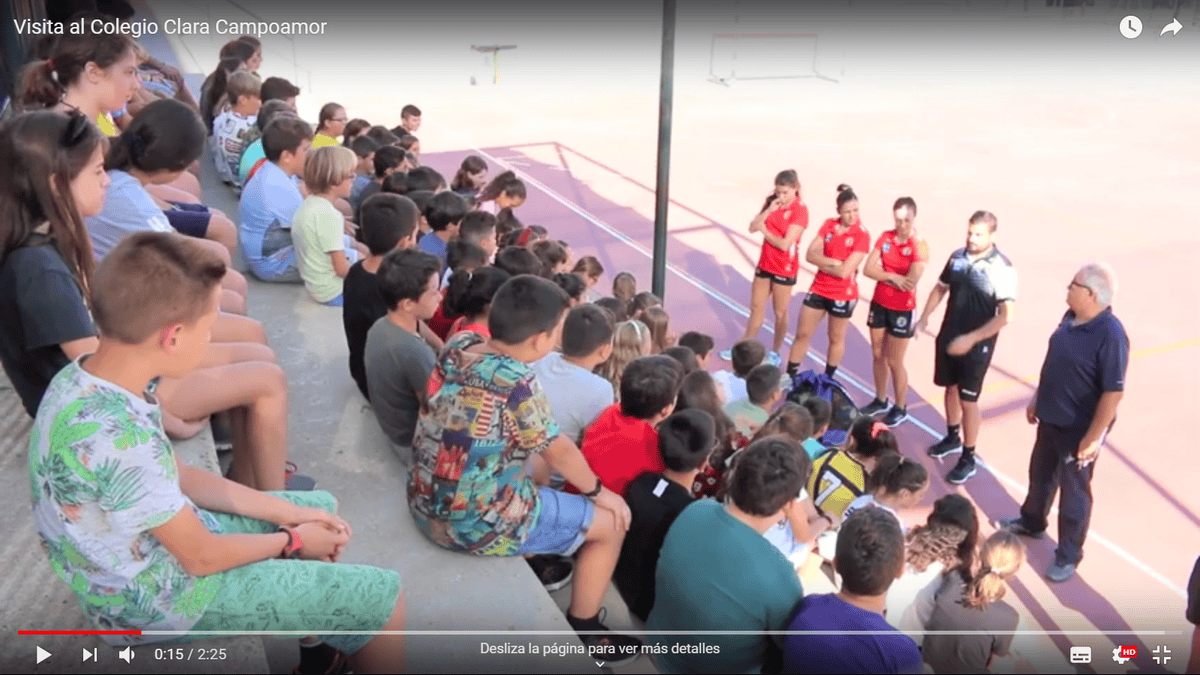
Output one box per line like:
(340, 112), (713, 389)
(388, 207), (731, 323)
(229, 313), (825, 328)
(862, 197), (929, 426)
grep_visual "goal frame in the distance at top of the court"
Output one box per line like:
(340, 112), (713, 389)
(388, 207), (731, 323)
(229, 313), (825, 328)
(708, 32), (838, 84)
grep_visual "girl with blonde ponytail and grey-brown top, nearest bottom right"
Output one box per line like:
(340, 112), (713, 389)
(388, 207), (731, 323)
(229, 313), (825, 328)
(922, 530), (1025, 673)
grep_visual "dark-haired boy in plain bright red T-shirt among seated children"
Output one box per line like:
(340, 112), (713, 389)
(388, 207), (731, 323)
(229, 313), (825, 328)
(581, 354), (683, 496)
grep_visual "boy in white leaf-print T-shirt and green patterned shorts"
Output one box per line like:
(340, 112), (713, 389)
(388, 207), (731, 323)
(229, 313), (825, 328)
(29, 232), (404, 673)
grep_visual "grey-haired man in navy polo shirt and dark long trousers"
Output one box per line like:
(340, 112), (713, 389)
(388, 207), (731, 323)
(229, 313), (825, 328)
(1002, 263), (1129, 581)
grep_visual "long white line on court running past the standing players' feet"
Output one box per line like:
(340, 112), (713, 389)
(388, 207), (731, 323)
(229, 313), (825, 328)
(472, 148), (1188, 598)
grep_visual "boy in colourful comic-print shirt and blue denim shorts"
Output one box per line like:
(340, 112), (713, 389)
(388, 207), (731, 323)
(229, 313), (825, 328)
(408, 275), (641, 665)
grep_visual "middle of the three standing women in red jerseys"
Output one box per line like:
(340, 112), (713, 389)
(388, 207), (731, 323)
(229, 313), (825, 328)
(787, 184), (871, 377)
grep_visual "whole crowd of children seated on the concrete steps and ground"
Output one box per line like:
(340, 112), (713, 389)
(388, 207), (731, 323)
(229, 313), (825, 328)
(0, 22), (1041, 673)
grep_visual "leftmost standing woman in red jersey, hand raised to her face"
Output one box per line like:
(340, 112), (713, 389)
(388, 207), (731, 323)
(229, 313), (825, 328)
(721, 169), (809, 365)
